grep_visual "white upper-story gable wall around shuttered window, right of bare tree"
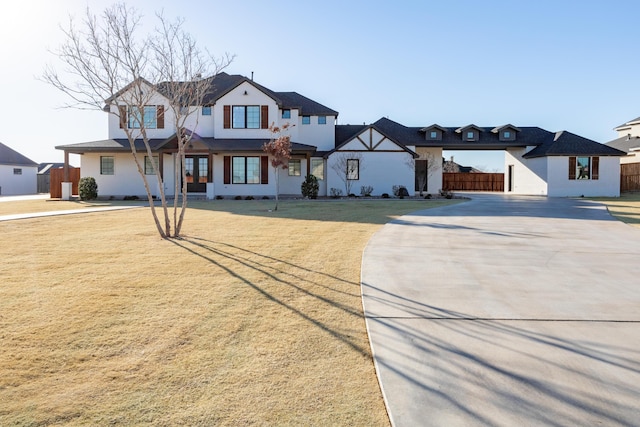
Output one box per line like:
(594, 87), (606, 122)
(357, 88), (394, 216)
(212, 82), (281, 138)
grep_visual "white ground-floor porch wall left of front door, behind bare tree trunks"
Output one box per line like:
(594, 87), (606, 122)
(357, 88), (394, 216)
(80, 153), (174, 197)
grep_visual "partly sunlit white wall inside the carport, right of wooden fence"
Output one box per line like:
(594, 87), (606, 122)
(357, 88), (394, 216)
(504, 147), (548, 196)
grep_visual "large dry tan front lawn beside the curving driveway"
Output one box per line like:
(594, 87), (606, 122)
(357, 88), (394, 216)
(0, 200), (460, 426)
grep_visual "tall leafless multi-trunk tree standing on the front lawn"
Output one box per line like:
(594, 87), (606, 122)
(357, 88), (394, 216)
(43, 3), (233, 238)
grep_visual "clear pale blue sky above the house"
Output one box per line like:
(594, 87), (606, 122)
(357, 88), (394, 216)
(0, 0), (640, 170)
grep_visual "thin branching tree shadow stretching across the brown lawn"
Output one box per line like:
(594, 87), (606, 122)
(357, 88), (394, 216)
(171, 237), (371, 357)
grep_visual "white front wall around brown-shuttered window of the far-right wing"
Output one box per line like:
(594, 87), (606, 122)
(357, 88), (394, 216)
(545, 156), (620, 197)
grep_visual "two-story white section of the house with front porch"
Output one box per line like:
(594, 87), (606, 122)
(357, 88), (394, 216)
(56, 73), (338, 198)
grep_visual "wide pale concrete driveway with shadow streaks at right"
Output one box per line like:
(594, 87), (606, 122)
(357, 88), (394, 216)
(362, 194), (640, 426)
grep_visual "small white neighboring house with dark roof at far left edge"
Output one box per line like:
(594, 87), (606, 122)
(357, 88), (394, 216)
(0, 143), (38, 196)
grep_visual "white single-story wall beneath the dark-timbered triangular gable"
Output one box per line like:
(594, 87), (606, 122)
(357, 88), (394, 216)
(326, 151), (415, 195)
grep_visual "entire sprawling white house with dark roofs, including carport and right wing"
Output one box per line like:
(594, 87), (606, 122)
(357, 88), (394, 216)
(56, 73), (624, 198)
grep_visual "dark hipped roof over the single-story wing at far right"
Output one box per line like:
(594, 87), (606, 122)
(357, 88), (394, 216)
(522, 131), (625, 159)
